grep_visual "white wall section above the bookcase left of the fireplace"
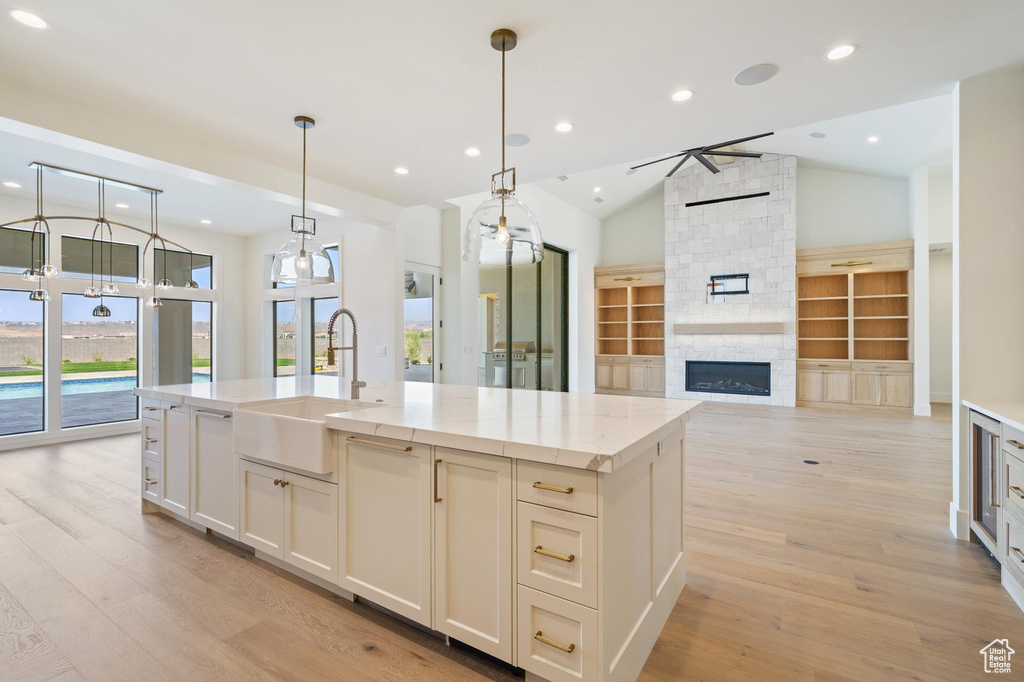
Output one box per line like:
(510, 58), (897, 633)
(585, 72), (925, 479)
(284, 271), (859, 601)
(597, 191), (665, 265)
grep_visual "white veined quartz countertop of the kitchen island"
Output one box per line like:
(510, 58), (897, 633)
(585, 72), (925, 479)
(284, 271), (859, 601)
(135, 377), (701, 472)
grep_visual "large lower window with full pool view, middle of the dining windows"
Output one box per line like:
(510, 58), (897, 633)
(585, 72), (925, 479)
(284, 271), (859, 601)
(60, 294), (138, 428)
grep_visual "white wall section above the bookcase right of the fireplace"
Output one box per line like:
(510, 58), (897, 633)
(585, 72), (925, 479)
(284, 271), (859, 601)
(797, 166), (913, 249)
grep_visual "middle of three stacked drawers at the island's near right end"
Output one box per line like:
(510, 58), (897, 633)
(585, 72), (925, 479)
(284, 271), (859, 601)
(516, 502), (597, 608)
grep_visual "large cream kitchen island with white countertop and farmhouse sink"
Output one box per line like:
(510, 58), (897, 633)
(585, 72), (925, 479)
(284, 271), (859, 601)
(136, 377), (700, 682)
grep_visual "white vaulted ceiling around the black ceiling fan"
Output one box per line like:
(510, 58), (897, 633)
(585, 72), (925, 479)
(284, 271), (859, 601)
(535, 95), (952, 219)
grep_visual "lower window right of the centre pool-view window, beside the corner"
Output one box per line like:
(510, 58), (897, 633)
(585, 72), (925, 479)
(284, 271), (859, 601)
(154, 298), (213, 385)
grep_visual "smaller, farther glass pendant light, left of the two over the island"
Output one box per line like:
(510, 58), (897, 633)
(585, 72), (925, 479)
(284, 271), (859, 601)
(270, 116), (334, 285)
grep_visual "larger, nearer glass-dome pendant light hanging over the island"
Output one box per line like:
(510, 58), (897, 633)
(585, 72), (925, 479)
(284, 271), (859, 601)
(462, 29), (544, 265)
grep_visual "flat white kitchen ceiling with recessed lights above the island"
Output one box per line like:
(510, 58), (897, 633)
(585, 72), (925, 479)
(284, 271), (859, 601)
(0, 0), (1024, 205)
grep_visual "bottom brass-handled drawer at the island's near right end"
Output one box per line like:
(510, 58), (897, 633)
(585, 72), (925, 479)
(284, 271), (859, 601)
(517, 585), (598, 682)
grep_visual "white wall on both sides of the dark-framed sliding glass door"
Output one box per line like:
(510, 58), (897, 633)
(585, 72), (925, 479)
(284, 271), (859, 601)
(442, 184), (601, 393)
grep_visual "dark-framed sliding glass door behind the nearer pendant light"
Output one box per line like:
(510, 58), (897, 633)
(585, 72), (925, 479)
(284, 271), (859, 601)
(477, 245), (568, 391)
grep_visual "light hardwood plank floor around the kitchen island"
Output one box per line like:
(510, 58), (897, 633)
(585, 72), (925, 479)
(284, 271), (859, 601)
(0, 404), (1024, 682)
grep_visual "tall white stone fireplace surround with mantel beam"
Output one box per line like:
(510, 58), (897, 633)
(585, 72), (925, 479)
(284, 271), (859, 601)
(665, 154), (797, 406)
